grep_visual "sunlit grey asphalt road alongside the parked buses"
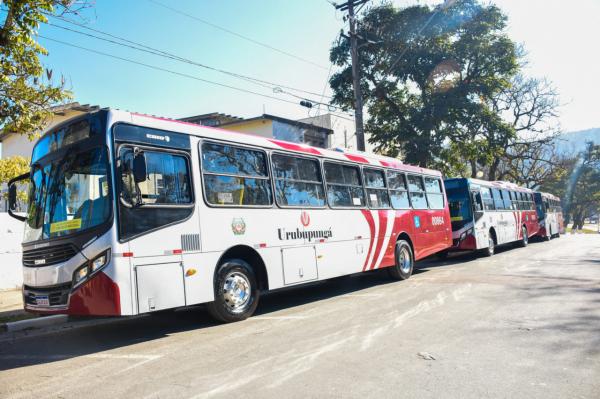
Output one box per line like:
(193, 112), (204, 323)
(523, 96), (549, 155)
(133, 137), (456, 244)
(0, 235), (600, 398)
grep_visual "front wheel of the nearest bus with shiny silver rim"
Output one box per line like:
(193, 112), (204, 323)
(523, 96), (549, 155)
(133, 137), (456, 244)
(207, 259), (260, 323)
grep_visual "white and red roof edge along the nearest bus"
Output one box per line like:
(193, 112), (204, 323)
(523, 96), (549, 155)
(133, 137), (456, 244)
(117, 109), (442, 177)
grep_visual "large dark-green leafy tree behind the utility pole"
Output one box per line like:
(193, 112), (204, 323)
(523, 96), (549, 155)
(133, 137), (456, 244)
(330, 0), (518, 169)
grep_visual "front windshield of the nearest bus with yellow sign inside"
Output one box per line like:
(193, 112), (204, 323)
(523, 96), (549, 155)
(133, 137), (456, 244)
(23, 147), (111, 242)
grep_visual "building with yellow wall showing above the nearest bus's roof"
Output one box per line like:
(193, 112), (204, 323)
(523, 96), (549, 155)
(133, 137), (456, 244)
(180, 112), (333, 148)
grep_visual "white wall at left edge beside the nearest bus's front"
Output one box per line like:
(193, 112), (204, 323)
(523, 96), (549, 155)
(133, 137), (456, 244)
(0, 212), (23, 290)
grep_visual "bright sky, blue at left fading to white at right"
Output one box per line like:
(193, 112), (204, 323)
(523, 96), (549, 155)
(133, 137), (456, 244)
(25, 0), (600, 131)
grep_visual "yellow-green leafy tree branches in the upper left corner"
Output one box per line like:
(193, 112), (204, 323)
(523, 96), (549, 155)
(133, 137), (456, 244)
(0, 0), (89, 138)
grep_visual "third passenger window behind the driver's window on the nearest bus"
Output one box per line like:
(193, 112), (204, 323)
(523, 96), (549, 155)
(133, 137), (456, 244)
(324, 162), (365, 208)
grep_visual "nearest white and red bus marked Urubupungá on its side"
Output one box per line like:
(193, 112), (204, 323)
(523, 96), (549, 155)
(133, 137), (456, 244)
(9, 110), (452, 321)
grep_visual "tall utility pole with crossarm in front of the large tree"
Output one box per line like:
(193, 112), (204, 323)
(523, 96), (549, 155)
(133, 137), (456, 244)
(335, 0), (369, 151)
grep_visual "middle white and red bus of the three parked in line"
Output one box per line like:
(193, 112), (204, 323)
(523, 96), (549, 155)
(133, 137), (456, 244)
(444, 178), (540, 256)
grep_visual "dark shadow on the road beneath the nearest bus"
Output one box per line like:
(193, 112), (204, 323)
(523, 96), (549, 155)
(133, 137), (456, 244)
(0, 270), (402, 371)
